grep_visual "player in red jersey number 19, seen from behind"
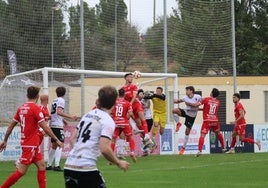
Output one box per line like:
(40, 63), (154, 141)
(111, 88), (137, 163)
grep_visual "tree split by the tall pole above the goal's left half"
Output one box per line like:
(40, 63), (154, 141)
(65, 2), (103, 69)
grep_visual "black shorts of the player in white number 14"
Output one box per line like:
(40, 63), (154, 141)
(64, 169), (106, 188)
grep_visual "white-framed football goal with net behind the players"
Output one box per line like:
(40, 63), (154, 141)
(0, 68), (178, 158)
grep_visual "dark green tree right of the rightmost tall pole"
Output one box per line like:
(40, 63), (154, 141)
(235, 0), (268, 75)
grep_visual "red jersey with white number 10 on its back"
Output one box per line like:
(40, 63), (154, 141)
(202, 97), (220, 121)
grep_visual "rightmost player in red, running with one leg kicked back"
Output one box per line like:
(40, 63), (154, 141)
(226, 93), (261, 154)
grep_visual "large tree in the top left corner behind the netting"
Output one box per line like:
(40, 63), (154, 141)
(0, 0), (65, 71)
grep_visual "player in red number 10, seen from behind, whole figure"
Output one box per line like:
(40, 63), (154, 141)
(186, 88), (226, 157)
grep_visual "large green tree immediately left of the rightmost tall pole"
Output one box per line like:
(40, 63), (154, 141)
(169, 0), (232, 75)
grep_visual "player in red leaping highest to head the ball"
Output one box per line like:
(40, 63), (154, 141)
(122, 73), (152, 145)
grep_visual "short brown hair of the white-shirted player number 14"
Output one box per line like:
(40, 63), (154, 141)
(98, 86), (118, 109)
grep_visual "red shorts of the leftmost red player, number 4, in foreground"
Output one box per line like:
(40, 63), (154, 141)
(20, 146), (43, 165)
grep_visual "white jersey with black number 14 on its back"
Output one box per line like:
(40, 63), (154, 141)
(65, 108), (115, 169)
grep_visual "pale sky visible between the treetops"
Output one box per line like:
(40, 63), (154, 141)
(71, 0), (178, 33)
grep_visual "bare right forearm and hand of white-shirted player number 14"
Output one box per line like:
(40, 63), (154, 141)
(100, 137), (129, 171)
